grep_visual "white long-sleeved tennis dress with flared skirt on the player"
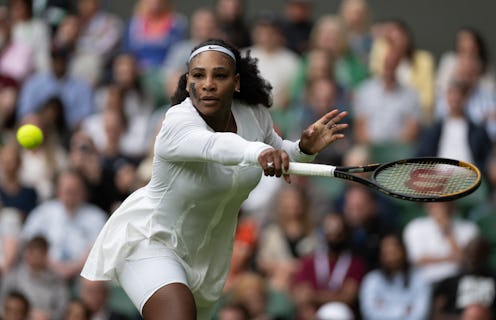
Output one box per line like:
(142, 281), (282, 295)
(81, 98), (313, 316)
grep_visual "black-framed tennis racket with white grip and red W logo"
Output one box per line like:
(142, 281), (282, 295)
(280, 158), (481, 202)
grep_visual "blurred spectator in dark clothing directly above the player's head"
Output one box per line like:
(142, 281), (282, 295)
(214, 0), (251, 48)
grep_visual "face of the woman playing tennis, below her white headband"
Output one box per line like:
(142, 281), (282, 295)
(186, 51), (239, 116)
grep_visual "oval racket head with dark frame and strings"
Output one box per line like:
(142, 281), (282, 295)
(371, 157), (481, 202)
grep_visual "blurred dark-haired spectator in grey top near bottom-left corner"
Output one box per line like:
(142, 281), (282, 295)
(1, 236), (70, 320)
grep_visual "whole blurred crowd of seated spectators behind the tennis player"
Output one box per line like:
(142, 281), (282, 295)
(0, 0), (496, 320)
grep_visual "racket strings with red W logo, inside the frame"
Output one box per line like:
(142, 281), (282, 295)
(374, 162), (478, 197)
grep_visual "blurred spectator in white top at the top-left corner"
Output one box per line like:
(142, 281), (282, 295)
(7, 0), (51, 72)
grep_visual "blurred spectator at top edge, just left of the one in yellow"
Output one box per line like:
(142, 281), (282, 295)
(339, 0), (373, 65)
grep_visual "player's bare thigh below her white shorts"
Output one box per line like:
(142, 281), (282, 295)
(142, 283), (196, 320)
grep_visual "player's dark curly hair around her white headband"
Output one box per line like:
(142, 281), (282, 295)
(170, 39), (272, 108)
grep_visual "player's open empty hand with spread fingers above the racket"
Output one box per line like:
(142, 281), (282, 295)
(300, 109), (348, 154)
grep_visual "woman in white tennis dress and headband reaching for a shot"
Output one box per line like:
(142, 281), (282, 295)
(81, 40), (347, 320)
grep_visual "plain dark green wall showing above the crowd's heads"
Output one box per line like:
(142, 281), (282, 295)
(105, 0), (496, 61)
